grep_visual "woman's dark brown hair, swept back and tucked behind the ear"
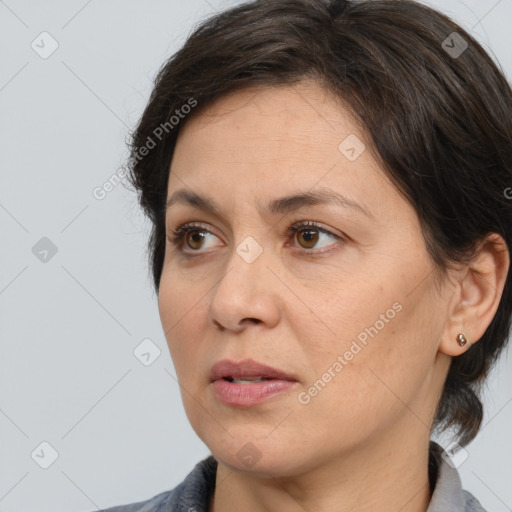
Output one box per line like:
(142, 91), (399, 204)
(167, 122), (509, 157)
(129, 0), (512, 446)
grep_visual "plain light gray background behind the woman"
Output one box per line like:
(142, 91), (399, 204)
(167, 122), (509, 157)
(0, 0), (512, 512)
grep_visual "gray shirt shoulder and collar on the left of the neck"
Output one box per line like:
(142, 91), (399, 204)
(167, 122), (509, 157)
(95, 455), (217, 512)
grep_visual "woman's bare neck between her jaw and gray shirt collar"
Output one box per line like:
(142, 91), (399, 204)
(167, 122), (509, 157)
(209, 436), (431, 512)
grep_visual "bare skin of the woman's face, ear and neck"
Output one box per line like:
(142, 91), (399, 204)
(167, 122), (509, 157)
(159, 81), (509, 512)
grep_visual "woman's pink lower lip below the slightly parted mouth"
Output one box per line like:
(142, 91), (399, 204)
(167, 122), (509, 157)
(212, 379), (297, 407)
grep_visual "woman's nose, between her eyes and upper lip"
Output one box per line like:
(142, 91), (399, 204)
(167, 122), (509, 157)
(209, 242), (284, 333)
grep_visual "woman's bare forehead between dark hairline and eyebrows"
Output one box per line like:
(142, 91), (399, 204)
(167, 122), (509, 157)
(168, 82), (412, 224)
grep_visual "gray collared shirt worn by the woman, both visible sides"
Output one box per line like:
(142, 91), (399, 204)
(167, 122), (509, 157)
(99, 441), (486, 512)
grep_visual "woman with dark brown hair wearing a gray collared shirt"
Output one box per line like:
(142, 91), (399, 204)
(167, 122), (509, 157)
(101, 0), (512, 512)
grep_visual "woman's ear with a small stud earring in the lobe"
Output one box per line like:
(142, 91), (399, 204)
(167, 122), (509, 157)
(439, 233), (510, 356)
